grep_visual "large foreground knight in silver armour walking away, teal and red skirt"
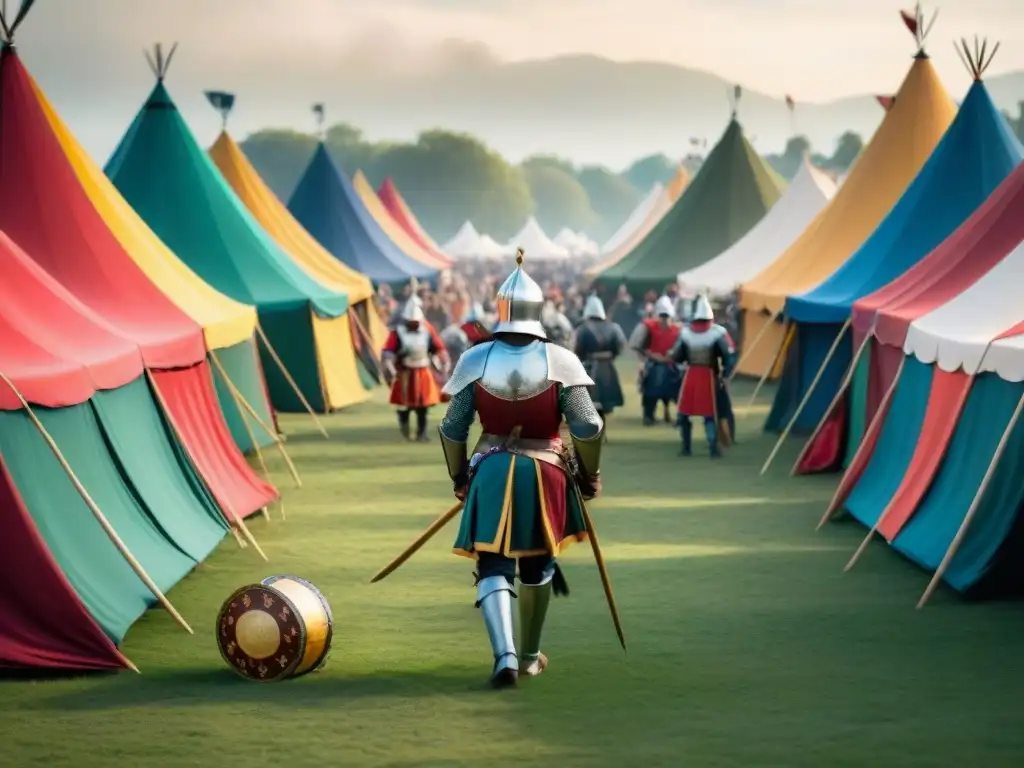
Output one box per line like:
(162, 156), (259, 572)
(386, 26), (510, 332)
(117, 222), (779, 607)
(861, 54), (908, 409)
(439, 251), (604, 687)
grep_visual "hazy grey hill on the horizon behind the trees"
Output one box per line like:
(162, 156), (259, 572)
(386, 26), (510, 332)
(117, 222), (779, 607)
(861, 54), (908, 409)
(266, 55), (1024, 169)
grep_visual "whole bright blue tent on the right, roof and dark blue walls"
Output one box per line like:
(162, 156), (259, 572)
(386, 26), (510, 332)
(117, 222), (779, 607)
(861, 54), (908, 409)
(765, 80), (1024, 433)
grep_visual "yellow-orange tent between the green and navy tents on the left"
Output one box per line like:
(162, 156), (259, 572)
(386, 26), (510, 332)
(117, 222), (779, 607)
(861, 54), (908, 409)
(210, 131), (387, 387)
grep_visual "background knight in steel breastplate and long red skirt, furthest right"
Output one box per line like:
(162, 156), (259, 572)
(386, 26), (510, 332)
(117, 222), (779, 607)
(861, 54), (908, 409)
(669, 296), (736, 458)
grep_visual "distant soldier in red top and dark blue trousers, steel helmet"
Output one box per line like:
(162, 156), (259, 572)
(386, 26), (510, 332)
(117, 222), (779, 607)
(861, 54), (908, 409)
(630, 296), (682, 427)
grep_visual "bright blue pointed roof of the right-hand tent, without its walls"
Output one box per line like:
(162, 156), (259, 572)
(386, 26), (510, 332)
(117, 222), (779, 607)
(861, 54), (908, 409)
(785, 80), (1022, 323)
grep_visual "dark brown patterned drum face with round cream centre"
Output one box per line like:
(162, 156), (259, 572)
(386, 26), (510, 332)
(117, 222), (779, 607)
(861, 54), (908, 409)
(217, 584), (306, 683)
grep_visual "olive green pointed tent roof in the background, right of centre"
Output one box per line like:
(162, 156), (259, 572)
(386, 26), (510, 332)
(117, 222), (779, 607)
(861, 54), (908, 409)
(596, 116), (785, 295)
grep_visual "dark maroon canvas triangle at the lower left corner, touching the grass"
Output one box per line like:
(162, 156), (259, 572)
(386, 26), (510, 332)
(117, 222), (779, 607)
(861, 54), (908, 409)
(0, 458), (126, 671)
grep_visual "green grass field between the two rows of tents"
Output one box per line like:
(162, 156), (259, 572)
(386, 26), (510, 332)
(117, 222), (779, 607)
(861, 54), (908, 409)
(0, 380), (1024, 768)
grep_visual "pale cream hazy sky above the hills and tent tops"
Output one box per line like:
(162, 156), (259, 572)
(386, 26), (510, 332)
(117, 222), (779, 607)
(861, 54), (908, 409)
(7, 0), (1024, 159)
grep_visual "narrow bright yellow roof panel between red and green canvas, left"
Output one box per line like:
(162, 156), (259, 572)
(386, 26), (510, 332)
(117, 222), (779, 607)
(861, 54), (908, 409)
(33, 74), (256, 349)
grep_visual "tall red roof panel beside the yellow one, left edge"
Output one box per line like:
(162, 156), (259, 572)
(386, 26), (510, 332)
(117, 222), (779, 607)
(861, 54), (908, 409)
(0, 46), (206, 368)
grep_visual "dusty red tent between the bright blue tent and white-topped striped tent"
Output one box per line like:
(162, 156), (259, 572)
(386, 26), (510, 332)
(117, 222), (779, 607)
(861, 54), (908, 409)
(798, 165), (1024, 479)
